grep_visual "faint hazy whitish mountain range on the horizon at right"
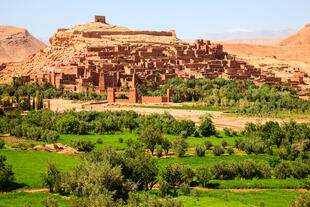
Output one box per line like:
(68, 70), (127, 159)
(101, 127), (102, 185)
(204, 29), (297, 45)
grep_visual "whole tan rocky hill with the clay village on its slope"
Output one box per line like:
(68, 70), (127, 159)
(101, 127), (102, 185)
(0, 16), (310, 90)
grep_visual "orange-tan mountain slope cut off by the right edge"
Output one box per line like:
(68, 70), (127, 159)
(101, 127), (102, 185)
(280, 24), (310, 46)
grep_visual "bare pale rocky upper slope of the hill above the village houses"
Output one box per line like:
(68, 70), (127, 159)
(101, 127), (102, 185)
(0, 16), (183, 82)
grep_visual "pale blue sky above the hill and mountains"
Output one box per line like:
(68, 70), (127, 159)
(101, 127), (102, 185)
(0, 0), (310, 40)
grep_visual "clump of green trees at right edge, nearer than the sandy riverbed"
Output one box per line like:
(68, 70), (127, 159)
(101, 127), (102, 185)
(242, 120), (310, 160)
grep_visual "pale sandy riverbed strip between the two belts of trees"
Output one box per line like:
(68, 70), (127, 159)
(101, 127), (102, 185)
(46, 99), (310, 130)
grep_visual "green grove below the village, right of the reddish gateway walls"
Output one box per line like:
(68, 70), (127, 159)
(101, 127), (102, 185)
(140, 78), (310, 115)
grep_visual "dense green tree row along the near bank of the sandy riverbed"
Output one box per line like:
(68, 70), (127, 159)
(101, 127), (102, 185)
(0, 109), (216, 145)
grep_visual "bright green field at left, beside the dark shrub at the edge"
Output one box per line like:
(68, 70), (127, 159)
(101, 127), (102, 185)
(0, 150), (80, 189)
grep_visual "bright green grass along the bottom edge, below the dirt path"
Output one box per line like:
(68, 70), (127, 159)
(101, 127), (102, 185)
(0, 190), (306, 207)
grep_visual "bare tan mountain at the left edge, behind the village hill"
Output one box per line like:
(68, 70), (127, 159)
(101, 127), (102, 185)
(0, 25), (47, 62)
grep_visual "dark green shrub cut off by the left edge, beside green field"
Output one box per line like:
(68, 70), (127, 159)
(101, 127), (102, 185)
(0, 155), (15, 192)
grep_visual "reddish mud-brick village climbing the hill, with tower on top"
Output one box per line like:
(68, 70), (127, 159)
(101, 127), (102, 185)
(6, 16), (303, 100)
